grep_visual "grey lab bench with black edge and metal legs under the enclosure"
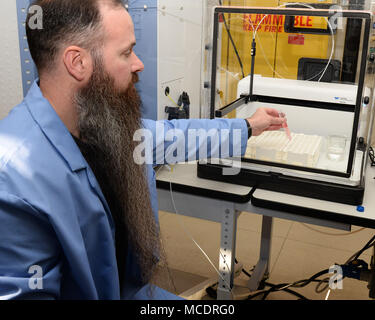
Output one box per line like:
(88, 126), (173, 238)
(156, 162), (375, 300)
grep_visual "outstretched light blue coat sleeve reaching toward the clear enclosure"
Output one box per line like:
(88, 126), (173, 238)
(141, 119), (248, 165)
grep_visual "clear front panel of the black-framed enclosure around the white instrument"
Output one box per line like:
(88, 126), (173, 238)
(211, 9), (372, 176)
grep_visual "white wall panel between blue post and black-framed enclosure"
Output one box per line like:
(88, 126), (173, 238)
(158, 0), (203, 119)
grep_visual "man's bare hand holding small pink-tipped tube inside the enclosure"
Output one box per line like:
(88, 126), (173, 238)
(246, 108), (288, 136)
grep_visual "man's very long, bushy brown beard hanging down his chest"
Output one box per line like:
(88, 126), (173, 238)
(75, 63), (161, 283)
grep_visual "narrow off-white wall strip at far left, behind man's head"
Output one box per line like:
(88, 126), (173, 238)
(0, 0), (23, 119)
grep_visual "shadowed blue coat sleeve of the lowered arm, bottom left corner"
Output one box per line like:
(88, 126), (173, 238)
(0, 191), (61, 300)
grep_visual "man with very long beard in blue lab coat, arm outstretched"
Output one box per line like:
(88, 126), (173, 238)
(0, 0), (285, 299)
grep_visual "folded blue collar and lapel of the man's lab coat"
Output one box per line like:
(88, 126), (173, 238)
(24, 79), (87, 171)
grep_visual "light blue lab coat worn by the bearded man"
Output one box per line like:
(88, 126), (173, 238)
(0, 82), (247, 299)
